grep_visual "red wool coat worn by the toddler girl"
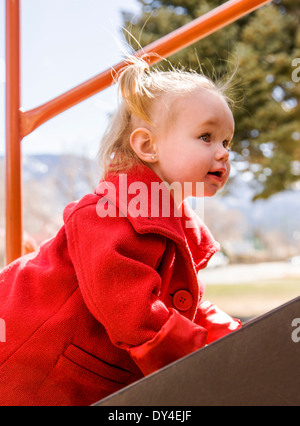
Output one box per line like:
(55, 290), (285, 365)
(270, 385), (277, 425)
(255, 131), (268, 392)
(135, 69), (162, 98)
(0, 167), (240, 406)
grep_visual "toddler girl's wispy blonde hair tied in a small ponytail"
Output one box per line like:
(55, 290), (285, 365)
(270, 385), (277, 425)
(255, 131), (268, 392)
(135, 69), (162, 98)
(99, 56), (231, 177)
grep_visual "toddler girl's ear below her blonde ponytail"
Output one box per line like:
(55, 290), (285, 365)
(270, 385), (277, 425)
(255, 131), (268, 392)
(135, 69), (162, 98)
(130, 127), (157, 164)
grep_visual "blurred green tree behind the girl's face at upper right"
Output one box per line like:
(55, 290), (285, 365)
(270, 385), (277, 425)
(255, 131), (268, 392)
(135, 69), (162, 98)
(124, 0), (300, 199)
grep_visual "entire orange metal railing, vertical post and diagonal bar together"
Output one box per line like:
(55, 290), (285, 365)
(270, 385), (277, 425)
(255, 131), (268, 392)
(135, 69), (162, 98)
(6, 0), (271, 263)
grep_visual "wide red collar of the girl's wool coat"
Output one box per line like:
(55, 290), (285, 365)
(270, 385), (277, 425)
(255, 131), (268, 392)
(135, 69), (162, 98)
(95, 165), (220, 269)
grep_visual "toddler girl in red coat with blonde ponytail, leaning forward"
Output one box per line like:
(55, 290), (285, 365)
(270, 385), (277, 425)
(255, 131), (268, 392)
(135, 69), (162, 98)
(0, 58), (240, 406)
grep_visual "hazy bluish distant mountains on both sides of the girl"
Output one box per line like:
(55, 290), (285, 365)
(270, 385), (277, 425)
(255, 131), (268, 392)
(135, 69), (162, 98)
(0, 154), (300, 231)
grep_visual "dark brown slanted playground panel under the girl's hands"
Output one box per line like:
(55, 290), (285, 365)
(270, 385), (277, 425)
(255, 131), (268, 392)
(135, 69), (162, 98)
(96, 298), (300, 407)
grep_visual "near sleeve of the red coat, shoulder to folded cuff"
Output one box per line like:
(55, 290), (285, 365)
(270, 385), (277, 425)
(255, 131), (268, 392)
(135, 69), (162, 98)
(66, 205), (207, 375)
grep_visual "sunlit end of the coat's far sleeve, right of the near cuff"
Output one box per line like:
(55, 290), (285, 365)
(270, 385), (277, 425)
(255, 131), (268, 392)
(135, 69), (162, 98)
(195, 300), (242, 344)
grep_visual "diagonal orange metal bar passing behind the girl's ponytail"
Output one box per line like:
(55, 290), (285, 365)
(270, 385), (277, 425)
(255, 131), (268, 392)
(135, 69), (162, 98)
(21, 0), (271, 137)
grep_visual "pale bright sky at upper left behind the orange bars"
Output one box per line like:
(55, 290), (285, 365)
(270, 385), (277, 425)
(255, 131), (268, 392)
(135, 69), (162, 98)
(0, 0), (140, 158)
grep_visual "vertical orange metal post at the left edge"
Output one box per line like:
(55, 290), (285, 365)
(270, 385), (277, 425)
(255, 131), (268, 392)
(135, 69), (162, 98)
(6, 0), (23, 263)
